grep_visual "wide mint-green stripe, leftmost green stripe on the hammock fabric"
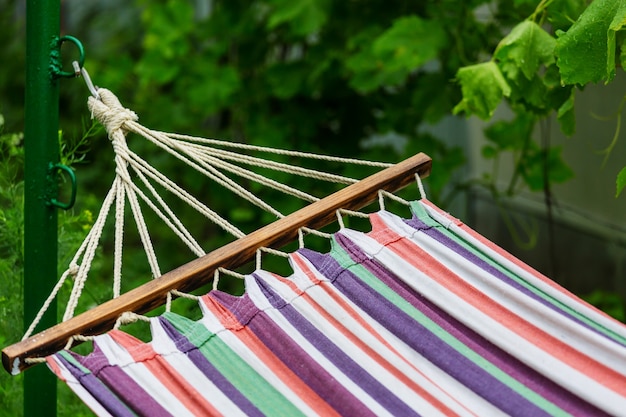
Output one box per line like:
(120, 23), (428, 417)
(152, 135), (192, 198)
(163, 312), (304, 417)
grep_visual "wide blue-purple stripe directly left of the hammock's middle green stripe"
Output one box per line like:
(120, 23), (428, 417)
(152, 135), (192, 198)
(300, 244), (547, 416)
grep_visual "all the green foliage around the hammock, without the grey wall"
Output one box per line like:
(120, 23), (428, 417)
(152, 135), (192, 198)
(0, 0), (626, 415)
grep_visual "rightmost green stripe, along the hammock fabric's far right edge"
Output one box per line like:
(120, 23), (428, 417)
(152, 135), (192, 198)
(411, 201), (626, 346)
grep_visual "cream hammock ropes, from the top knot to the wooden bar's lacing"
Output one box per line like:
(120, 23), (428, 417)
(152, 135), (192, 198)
(24, 89), (400, 338)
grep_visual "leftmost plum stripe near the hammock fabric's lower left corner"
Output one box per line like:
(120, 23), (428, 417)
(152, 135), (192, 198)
(74, 340), (171, 417)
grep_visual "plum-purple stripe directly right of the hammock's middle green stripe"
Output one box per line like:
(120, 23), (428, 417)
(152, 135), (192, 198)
(325, 235), (604, 415)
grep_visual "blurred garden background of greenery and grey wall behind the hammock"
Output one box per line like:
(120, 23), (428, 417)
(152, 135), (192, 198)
(0, 0), (626, 416)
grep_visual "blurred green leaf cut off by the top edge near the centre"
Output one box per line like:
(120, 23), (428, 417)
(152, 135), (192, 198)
(267, 0), (328, 36)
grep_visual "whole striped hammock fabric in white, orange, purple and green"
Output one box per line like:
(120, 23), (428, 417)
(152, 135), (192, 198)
(47, 200), (626, 417)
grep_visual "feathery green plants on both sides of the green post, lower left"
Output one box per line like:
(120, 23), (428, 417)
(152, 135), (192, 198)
(0, 114), (93, 416)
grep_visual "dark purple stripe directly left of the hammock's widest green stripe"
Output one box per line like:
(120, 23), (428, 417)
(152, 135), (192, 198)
(159, 313), (263, 416)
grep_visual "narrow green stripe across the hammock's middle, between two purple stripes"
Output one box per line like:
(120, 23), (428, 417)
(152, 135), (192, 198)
(330, 239), (569, 415)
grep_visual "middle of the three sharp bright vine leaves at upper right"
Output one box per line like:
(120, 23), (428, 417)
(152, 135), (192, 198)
(494, 20), (556, 80)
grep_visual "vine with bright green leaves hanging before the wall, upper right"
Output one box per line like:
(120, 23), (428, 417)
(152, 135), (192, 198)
(455, 0), (626, 201)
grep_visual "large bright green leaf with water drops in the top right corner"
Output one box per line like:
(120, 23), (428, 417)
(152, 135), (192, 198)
(555, 0), (626, 85)
